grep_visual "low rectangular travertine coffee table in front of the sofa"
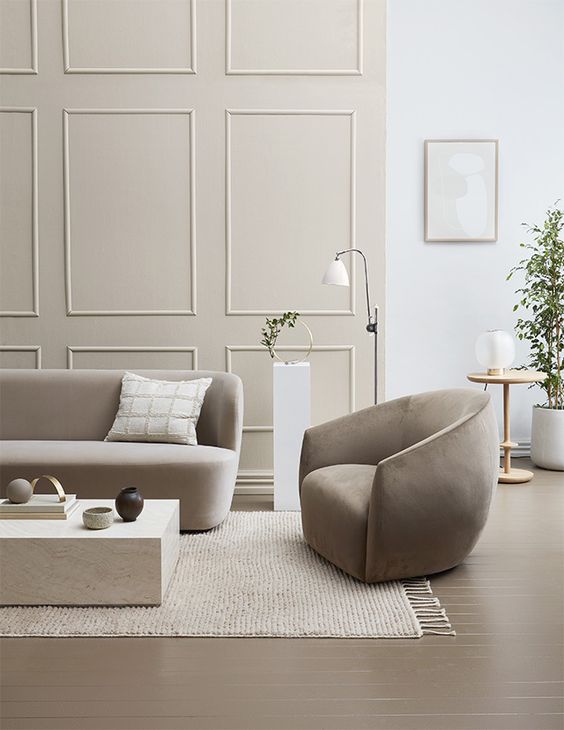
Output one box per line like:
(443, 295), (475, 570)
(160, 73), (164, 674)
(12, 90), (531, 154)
(0, 499), (180, 606)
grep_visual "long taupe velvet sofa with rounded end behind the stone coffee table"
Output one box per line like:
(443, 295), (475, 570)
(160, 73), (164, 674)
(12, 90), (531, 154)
(0, 370), (243, 530)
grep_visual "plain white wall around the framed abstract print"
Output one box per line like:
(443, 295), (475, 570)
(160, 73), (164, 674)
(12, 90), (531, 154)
(386, 0), (564, 441)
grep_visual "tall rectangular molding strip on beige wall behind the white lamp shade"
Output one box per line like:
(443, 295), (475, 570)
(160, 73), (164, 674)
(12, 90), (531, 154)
(225, 109), (356, 317)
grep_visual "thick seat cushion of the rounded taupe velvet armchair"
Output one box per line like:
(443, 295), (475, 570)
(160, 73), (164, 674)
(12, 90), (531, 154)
(301, 464), (376, 580)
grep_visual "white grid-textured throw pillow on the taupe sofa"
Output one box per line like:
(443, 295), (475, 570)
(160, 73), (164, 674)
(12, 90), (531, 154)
(105, 373), (212, 446)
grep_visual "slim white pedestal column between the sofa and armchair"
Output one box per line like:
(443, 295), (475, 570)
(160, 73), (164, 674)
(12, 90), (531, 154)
(272, 362), (311, 510)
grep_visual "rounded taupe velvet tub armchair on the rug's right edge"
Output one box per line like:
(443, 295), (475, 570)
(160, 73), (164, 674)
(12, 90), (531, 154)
(300, 389), (499, 583)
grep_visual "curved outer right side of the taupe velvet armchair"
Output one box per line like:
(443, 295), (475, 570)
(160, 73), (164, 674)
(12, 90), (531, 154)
(366, 401), (499, 581)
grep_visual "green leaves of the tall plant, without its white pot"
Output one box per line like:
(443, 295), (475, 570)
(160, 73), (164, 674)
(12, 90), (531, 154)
(507, 204), (564, 410)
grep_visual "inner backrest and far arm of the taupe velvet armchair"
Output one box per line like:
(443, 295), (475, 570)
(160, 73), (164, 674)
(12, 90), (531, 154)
(299, 398), (408, 489)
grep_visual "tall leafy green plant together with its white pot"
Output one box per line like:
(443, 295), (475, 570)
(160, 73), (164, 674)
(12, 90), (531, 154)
(507, 205), (564, 470)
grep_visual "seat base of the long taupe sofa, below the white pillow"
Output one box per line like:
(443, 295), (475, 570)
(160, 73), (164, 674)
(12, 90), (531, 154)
(0, 440), (238, 530)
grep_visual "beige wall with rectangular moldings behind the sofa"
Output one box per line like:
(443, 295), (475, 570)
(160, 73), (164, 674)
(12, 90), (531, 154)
(0, 0), (386, 489)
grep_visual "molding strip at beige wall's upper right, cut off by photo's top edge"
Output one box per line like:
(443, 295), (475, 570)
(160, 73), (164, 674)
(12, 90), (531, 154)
(225, 0), (364, 76)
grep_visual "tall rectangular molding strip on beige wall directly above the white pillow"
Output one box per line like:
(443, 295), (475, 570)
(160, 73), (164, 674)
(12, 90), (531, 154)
(63, 109), (197, 317)
